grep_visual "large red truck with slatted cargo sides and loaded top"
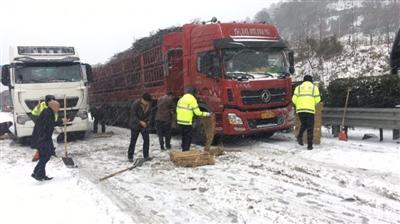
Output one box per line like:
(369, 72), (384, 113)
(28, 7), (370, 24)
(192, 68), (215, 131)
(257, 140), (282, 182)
(89, 19), (294, 142)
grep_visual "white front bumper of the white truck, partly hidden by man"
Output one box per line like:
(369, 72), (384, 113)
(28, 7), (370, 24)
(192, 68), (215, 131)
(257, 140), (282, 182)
(16, 117), (89, 138)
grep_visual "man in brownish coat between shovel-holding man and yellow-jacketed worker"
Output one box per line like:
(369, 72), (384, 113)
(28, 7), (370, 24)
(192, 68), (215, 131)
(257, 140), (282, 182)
(156, 91), (175, 150)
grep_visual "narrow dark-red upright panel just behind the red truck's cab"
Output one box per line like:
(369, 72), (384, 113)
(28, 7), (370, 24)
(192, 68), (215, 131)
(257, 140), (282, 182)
(167, 48), (184, 96)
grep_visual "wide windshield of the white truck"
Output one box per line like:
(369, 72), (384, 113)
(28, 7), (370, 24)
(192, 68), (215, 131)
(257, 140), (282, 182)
(15, 63), (82, 83)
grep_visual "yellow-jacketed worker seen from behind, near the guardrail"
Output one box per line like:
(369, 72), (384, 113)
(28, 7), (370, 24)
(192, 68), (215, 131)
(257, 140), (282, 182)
(292, 75), (321, 150)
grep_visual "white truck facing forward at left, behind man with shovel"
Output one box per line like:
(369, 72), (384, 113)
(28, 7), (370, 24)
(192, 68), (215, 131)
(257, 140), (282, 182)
(1, 46), (92, 139)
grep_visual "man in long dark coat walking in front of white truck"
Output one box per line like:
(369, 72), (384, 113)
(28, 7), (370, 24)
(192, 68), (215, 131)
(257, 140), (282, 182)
(31, 100), (62, 181)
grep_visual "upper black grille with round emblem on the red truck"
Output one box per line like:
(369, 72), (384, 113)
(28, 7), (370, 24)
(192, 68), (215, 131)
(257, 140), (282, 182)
(241, 89), (287, 105)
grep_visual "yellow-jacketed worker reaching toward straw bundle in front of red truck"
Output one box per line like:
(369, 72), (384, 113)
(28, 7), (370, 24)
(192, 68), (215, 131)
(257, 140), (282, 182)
(176, 87), (211, 151)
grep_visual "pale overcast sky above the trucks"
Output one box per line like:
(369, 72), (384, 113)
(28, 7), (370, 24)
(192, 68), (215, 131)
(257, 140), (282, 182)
(0, 0), (278, 64)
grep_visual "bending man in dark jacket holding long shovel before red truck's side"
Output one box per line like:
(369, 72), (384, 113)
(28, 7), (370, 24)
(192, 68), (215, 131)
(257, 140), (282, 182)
(128, 93), (151, 162)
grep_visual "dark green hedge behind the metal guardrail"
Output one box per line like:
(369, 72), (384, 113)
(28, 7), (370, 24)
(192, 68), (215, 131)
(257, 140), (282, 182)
(324, 75), (400, 108)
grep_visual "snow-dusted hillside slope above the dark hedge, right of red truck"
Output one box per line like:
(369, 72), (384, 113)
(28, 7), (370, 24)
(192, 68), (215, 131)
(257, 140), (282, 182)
(294, 44), (389, 84)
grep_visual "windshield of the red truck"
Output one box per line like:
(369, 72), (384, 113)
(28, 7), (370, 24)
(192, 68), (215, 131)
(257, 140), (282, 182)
(223, 48), (288, 79)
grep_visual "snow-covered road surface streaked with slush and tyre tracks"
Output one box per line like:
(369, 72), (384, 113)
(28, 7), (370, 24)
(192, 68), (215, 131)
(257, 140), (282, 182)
(0, 112), (400, 224)
